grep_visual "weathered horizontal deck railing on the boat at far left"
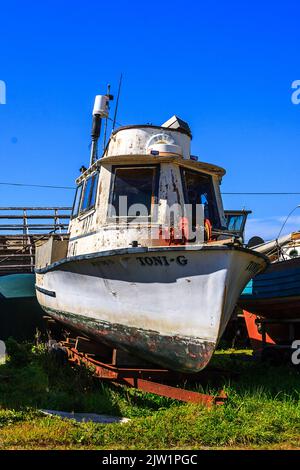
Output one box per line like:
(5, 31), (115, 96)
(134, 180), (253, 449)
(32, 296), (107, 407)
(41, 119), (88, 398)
(0, 207), (71, 275)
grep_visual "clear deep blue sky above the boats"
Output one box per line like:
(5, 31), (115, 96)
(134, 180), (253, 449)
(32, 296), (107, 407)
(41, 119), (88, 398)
(0, 0), (300, 238)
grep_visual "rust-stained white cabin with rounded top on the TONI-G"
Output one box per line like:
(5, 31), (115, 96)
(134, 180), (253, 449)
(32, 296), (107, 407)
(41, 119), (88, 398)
(68, 116), (226, 256)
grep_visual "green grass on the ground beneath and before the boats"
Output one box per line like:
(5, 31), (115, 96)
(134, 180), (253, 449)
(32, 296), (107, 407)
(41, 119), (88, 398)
(0, 342), (300, 449)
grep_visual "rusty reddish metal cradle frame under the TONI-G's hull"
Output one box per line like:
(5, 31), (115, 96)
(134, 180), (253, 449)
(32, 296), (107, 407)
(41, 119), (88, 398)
(60, 338), (227, 407)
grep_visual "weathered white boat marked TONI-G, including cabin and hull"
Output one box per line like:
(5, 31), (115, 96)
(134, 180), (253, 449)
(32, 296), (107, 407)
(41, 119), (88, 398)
(35, 91), (268, 373)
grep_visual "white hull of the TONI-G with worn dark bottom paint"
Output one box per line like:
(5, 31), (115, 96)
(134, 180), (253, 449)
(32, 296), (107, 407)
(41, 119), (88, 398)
(36, 246), (266, 372)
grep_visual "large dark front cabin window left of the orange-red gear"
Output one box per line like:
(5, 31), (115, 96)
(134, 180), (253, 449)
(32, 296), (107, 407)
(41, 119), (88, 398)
(110, 167), (157, 219)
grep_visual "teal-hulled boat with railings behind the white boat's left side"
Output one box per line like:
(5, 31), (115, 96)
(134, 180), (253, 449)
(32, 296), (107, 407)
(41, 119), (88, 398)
(0, 207), (70, 341)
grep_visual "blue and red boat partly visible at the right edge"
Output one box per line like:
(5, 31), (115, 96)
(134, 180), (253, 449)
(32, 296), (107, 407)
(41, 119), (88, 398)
(239, 232), (300, 354)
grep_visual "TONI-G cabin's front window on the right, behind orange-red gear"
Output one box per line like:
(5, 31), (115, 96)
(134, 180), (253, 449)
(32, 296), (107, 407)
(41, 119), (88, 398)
(182, 170), (220, 228)
